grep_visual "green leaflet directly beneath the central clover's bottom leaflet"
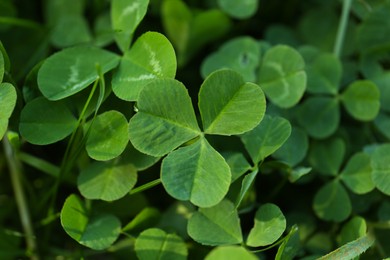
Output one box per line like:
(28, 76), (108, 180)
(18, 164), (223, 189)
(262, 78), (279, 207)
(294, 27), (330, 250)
(187, 200), (242, 246)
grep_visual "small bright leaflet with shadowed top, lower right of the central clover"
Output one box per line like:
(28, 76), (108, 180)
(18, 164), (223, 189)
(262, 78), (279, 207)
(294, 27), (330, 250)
(246, 203), (286, 247)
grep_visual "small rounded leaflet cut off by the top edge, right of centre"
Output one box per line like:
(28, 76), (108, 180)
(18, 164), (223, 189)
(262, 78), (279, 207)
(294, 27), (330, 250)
(217, 0), (259, 19)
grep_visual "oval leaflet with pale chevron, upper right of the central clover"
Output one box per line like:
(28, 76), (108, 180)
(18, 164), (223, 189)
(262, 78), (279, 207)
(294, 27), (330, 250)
(259, 45), (306, 108)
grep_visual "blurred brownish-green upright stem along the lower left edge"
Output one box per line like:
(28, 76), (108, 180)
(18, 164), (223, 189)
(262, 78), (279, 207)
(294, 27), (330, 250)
(3, 135), (39, 260)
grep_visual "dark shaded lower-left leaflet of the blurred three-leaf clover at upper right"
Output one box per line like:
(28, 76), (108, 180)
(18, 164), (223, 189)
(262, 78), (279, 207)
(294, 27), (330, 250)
(297, 96), (340, 139)
